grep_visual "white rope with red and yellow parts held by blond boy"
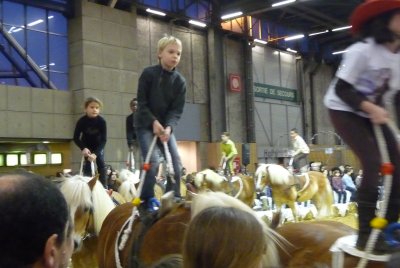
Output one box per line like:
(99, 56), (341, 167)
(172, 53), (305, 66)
(114, 135), (157, 268)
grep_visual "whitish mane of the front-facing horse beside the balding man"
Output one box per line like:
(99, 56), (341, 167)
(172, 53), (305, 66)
(60, 175), (115, 234)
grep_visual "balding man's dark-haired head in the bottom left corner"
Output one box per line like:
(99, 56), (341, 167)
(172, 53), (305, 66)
(0, 172), (73, 268)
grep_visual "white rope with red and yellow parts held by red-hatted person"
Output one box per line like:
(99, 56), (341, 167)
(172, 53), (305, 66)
(357, 122), (398, 268)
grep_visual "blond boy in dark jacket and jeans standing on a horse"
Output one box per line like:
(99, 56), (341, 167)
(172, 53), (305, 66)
(134, 36), (186, 211)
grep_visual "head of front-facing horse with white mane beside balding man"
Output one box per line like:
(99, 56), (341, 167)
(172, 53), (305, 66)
(60, 175), (116, 268)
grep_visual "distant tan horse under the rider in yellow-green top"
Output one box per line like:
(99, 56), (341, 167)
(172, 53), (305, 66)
(186, 169), (256, 207)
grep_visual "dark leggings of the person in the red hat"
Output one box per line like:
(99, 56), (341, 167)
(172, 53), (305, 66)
(329, 110), (400, 222)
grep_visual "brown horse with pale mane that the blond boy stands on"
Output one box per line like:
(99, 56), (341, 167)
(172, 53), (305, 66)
(98, 192), (285, 268)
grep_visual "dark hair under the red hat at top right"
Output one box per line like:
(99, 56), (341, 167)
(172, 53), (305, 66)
(359, 9), (400, 44)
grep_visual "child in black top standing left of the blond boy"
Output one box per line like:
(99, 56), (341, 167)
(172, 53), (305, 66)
(74, 97), (108, 189)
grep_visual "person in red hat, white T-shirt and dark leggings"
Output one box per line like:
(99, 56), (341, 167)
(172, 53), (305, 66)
(324, 0), (400, 253)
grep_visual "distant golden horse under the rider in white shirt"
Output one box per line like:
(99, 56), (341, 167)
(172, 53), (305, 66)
(255, 164), (333, 221)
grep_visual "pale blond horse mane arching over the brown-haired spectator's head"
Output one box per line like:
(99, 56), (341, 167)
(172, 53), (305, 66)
(191, 192), (289, 267)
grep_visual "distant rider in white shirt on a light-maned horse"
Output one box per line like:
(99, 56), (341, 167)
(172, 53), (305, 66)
(290, 128), (310, 174)
